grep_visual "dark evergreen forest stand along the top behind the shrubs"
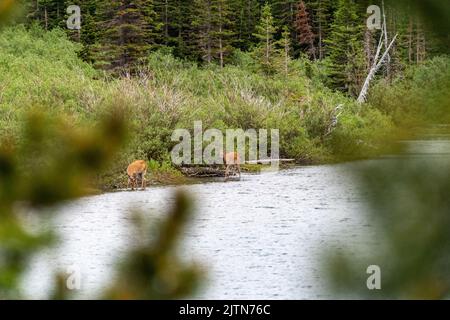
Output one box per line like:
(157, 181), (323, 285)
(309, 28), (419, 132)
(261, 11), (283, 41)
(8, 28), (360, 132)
(17, 0), (448, 77)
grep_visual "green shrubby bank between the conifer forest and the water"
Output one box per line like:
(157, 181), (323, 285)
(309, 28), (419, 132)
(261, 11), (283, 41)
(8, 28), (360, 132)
(0, 26), (442, 189)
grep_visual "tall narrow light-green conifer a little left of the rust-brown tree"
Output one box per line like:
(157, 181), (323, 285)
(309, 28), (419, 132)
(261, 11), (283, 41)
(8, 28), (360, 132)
(254, 2), (276, 73)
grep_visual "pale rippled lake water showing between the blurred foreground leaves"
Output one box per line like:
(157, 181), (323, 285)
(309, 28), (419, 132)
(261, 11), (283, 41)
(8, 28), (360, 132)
(23, 134), (450, 299)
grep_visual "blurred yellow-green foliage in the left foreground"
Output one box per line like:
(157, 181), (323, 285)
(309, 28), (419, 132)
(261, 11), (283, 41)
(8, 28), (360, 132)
(0, 111), (126, 298)
